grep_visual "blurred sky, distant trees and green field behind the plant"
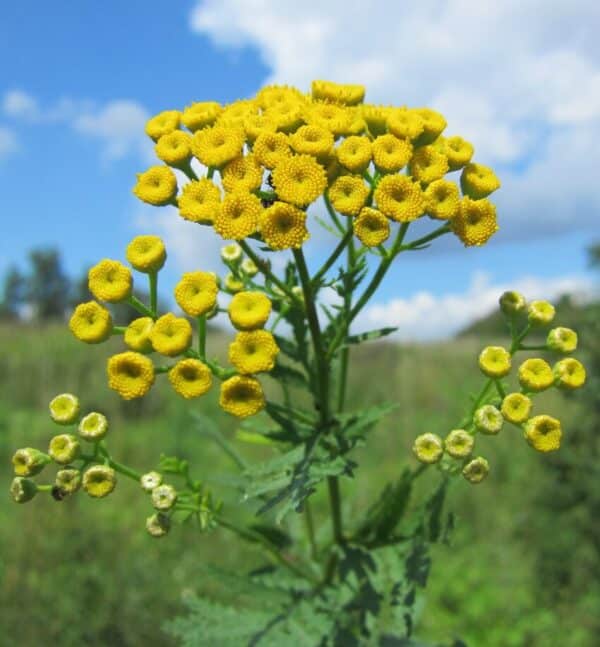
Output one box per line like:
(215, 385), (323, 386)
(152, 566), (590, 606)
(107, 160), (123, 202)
(0, 0), (600, 647)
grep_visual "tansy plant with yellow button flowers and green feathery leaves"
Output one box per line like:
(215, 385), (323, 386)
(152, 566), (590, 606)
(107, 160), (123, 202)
(11, 81), (585, 646)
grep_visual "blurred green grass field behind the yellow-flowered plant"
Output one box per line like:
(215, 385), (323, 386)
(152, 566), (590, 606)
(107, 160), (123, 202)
(0, 326), (600, 647)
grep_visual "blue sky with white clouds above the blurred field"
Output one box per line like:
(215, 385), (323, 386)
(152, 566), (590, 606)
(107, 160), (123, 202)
(0, 0), (600, 337)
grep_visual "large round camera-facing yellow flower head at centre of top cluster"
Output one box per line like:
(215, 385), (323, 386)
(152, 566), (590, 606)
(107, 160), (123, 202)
(273, 155), (327, 207)
